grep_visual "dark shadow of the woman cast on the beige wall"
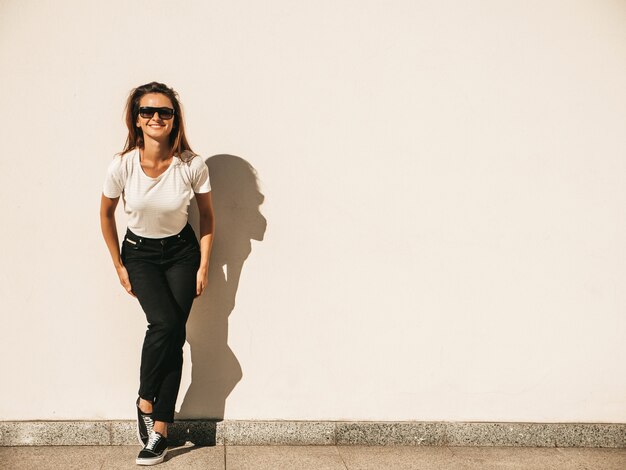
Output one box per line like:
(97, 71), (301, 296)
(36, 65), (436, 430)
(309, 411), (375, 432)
(176, 155), (267, 419)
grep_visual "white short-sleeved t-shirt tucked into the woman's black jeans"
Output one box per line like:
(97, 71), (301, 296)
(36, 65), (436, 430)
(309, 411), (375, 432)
(102, 149), (211, 238)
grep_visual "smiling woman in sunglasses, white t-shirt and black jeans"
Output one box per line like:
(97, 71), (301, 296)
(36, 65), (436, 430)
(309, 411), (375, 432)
(100, 82), (214, 465)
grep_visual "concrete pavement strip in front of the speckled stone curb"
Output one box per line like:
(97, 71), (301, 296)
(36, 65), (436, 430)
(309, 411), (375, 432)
(0, 445), (626, 470)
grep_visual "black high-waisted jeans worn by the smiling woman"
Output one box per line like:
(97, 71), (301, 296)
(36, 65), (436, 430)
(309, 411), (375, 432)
(121, 224), (200, 423)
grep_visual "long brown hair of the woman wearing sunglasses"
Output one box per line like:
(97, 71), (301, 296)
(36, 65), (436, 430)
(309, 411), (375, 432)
(120, 82), (195, 157)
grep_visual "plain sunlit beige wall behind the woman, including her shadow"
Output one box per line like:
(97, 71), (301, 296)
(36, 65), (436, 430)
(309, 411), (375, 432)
(0, 0), (626, 422)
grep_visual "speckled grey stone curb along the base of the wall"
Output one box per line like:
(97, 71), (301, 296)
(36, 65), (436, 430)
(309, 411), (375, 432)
(0, 420), (626, 448)
